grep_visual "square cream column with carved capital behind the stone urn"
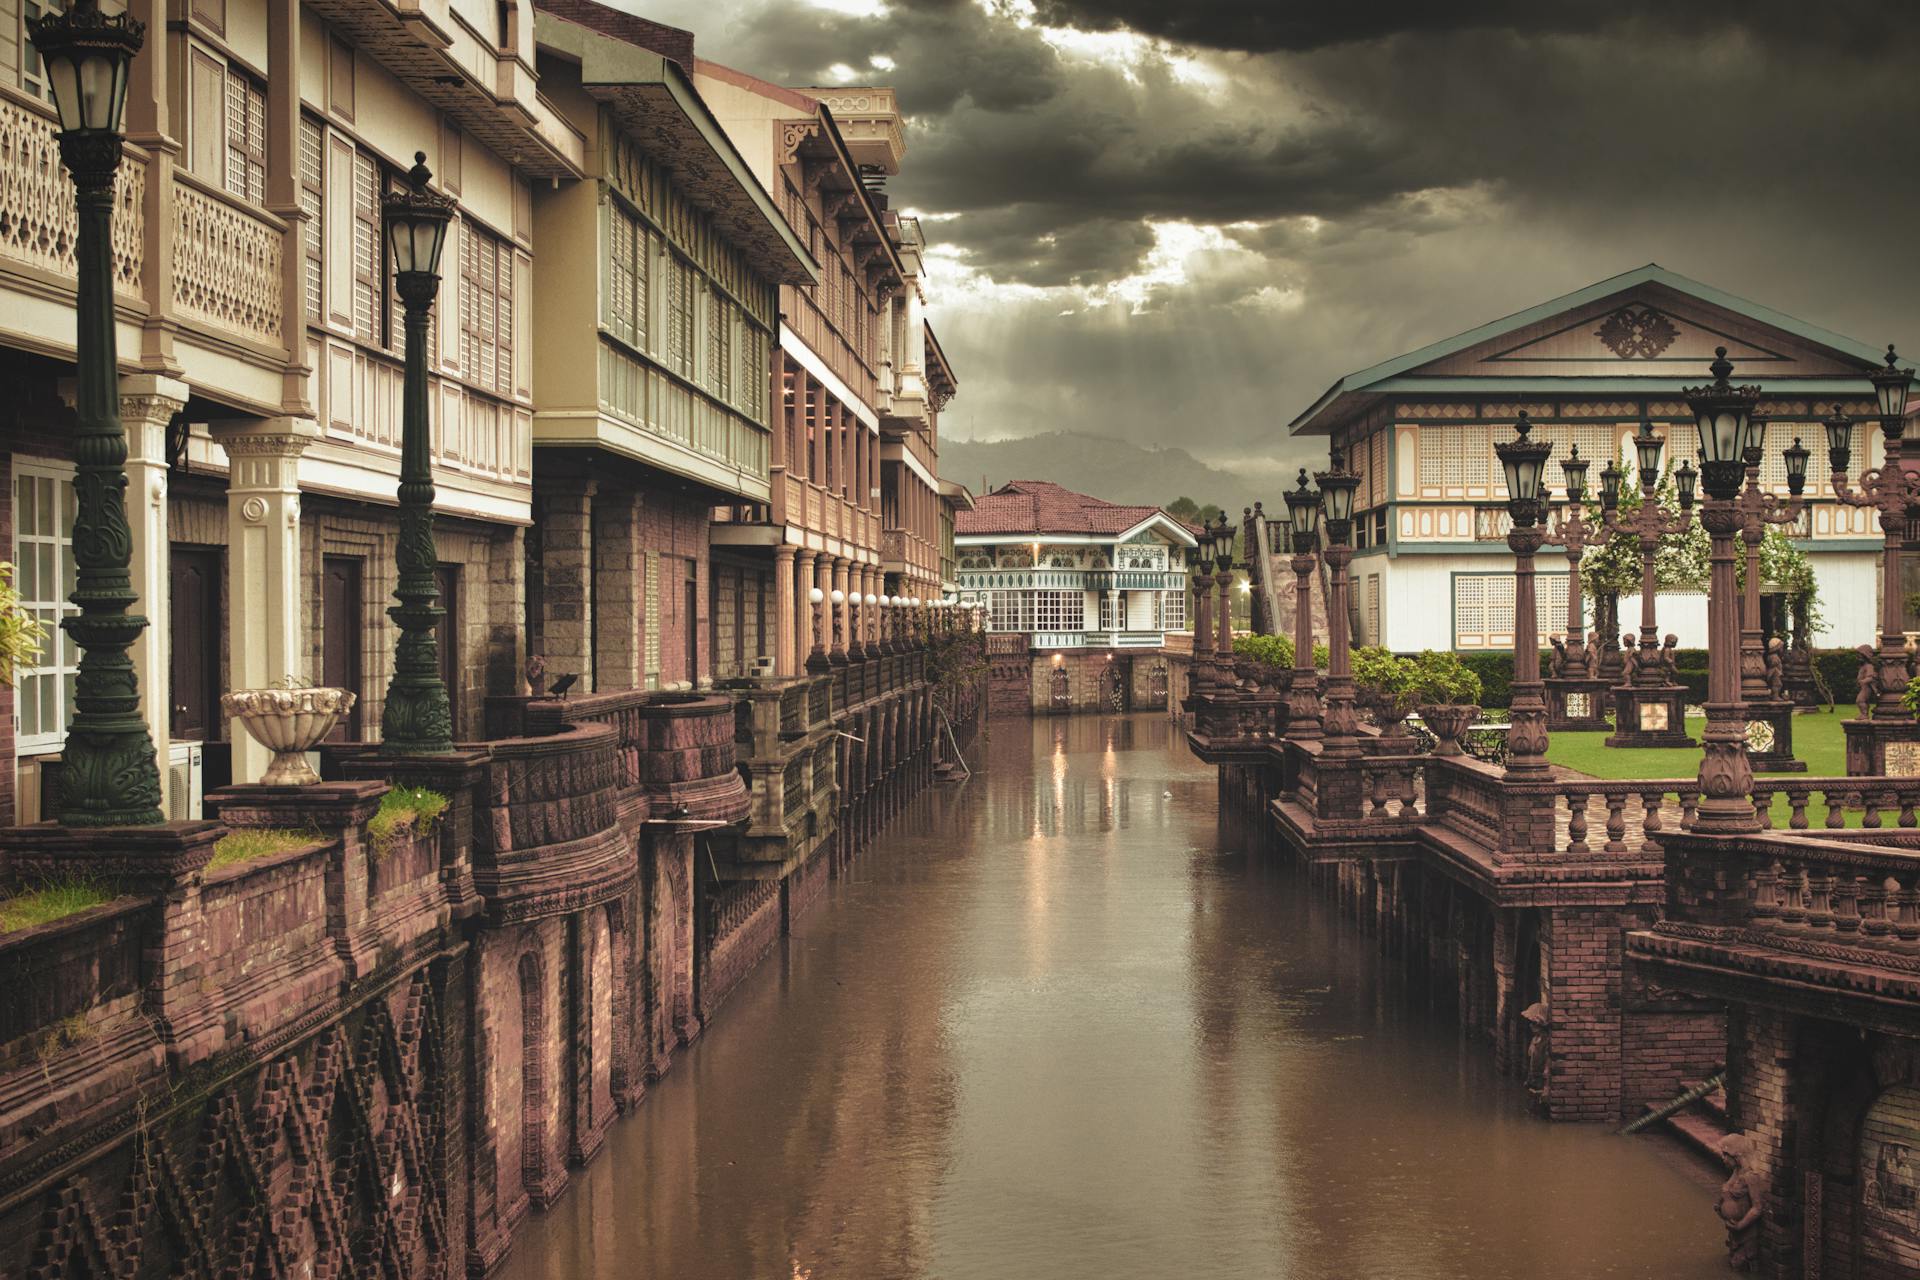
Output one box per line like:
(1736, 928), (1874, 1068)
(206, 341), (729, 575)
(213, 418), (321, 783)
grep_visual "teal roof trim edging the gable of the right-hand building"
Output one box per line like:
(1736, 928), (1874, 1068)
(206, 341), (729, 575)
(1286, 263), (1884, 436)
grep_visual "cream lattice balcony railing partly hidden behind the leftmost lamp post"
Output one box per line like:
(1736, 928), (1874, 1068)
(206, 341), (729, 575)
(0, 94), (143, 297)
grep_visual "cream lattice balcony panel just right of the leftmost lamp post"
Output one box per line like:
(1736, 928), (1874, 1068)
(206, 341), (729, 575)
(171, 175), (286, 345)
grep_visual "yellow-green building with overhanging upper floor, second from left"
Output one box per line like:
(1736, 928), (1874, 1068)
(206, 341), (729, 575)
(526, 0), (820, 693)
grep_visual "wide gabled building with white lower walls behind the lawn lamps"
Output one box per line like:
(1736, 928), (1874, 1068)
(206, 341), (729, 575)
(1290, 265), (1884, 651)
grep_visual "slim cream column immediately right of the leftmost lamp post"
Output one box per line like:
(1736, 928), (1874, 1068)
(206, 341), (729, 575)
(121, 374), (188, 782)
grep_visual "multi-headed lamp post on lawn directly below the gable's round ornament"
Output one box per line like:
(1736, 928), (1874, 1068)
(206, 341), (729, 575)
(1599, 422), (1699, 747)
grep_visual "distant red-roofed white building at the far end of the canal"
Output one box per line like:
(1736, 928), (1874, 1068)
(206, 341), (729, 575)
(954, 480), (1194, 710)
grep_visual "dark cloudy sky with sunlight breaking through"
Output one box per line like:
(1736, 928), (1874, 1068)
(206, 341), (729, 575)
(618, 0), (1920, 479)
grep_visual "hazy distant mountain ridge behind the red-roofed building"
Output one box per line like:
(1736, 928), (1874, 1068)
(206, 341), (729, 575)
(941, 432), (1325, 512)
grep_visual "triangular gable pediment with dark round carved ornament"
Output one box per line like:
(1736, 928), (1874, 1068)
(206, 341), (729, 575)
(1405, 282), (1862, 380)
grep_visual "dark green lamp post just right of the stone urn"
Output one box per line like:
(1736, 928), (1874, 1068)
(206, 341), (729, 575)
(380, 152), (453, 754)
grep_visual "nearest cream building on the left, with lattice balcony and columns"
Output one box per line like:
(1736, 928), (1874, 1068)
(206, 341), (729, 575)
(0, 0), (588, 819)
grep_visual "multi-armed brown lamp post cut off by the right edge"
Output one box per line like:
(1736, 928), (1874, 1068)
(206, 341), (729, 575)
(1826, 345), (1920, 722)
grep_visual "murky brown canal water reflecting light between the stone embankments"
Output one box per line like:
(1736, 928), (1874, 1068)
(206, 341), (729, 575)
(505, 716), (1726, 1280)
